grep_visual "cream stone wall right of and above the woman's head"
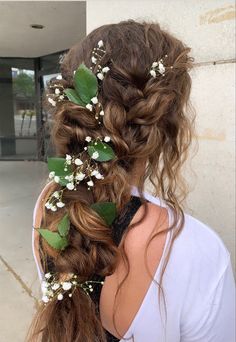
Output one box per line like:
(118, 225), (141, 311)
(87, 0), (235, 263)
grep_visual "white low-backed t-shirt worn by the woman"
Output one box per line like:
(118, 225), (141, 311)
(32, 187), (235, 342)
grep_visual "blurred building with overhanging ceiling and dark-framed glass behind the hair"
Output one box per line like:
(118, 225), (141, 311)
(0, 1), (86, 160)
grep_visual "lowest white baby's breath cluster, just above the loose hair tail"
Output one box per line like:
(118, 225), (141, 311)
(41, 272), (104, 304)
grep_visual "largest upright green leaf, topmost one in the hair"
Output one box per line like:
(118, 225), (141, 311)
(74, 63), (98, 104)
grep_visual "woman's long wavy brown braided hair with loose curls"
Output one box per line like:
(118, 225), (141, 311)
(28, 20), (194, 342)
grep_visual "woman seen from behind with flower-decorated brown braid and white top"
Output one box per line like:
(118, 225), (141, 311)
(28, 20), (234, 342)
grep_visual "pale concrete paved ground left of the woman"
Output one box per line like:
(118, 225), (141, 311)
(0, 161), (48, 342)
